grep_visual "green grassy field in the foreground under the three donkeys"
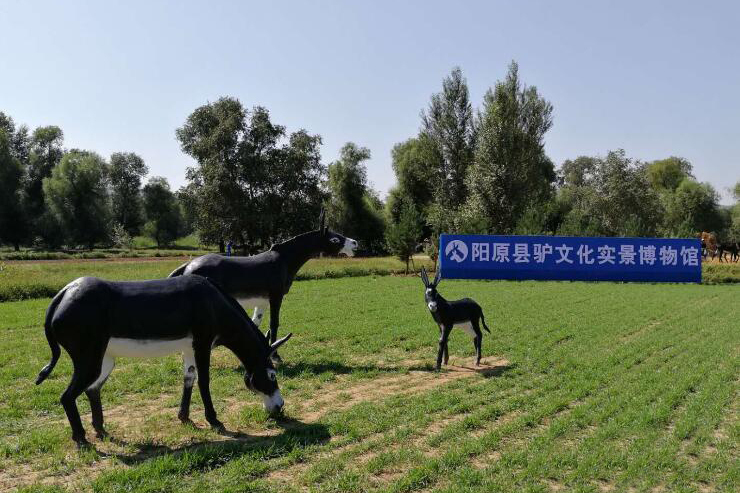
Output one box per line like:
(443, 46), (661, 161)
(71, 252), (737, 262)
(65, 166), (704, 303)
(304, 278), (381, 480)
(0, 274), (740, 492)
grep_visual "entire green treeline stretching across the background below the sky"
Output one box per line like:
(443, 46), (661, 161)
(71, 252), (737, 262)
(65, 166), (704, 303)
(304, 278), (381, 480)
(0, 62), (740, 260)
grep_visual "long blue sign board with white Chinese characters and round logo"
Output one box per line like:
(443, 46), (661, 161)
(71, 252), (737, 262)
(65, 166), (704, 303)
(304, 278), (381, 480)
(439, 235), (701, 282)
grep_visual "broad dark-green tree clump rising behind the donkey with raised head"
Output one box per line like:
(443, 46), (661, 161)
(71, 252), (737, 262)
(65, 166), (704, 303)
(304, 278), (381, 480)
(176, 98), (324, 251)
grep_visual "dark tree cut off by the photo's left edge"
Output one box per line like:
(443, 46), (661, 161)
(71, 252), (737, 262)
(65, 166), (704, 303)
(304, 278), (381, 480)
(0, 127), (27, 250)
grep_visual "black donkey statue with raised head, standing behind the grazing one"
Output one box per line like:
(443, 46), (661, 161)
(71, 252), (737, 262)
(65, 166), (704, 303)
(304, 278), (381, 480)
(170, 211), (357, 363)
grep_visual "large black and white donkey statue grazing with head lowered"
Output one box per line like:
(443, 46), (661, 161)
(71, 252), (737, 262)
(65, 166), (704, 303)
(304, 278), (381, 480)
(36, 276), (292, 445)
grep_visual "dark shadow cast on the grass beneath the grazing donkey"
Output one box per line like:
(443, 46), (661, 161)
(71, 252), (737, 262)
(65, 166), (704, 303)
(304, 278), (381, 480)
(95, 418), (331, 468)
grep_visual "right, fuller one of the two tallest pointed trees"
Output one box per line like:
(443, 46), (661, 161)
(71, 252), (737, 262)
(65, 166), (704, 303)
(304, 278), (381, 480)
(465, 62), (555, 233)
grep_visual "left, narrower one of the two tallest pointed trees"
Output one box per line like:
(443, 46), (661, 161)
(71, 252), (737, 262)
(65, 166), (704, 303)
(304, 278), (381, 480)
(421, 67), (476, 209)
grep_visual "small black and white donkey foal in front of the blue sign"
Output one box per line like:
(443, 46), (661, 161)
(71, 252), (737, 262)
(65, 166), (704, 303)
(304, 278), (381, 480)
(421, 267), (491, 370)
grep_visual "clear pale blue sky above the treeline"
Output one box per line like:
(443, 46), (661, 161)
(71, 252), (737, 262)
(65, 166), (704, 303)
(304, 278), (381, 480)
(0, 0), (740, 203)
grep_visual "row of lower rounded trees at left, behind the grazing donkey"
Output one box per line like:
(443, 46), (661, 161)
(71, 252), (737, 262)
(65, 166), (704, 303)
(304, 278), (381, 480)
(0, 112), (190, 250)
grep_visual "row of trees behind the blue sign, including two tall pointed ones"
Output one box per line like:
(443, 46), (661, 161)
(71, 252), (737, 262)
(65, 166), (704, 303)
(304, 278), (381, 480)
(386, 62), (740, 270)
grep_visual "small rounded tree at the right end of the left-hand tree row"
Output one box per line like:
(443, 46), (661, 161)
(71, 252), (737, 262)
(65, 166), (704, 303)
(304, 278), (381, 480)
(142, 176), (182, 247)
